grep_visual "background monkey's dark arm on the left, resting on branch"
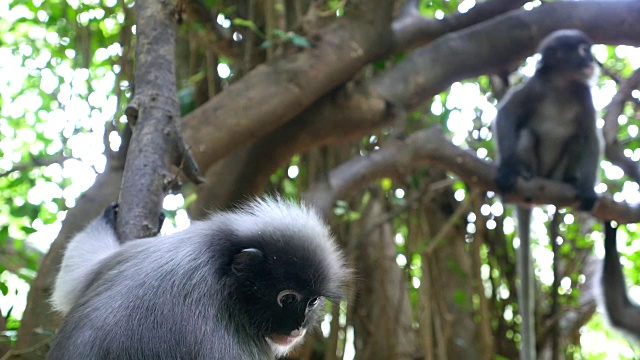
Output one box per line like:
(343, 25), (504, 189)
(495, 83), (532, 193)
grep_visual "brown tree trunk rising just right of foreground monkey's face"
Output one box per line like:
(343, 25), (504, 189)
(350, 195), (418, 360)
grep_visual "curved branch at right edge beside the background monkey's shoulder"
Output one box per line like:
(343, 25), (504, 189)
(603, 70), (640, 183)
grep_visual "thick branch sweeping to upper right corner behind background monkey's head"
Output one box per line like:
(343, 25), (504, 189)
(192, 1), (640, 208)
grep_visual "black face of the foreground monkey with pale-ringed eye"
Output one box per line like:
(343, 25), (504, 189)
(225, 233), (341, 354)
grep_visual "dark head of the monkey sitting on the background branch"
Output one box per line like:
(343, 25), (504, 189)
(539, 30), (595, 79)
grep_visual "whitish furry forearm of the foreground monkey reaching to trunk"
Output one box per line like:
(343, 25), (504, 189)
(50, 216), (120, 314)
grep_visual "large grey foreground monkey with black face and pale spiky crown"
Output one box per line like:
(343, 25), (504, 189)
(48, 199), (349, 360)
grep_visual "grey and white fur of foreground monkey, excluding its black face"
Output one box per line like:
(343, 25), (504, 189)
(48, 199), (348, 360)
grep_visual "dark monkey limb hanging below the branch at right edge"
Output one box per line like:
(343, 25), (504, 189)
(600, 221), (640, 338)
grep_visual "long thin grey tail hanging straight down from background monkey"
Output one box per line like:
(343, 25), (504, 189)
(516, 206), (536, 360)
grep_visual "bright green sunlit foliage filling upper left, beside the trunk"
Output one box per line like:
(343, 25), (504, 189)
(0, 0), (131, 329)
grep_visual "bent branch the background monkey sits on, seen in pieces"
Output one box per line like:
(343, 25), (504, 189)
(305, 126), (640, 223)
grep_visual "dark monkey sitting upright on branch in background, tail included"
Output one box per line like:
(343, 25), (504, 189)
(494, 30), (601, 360)
